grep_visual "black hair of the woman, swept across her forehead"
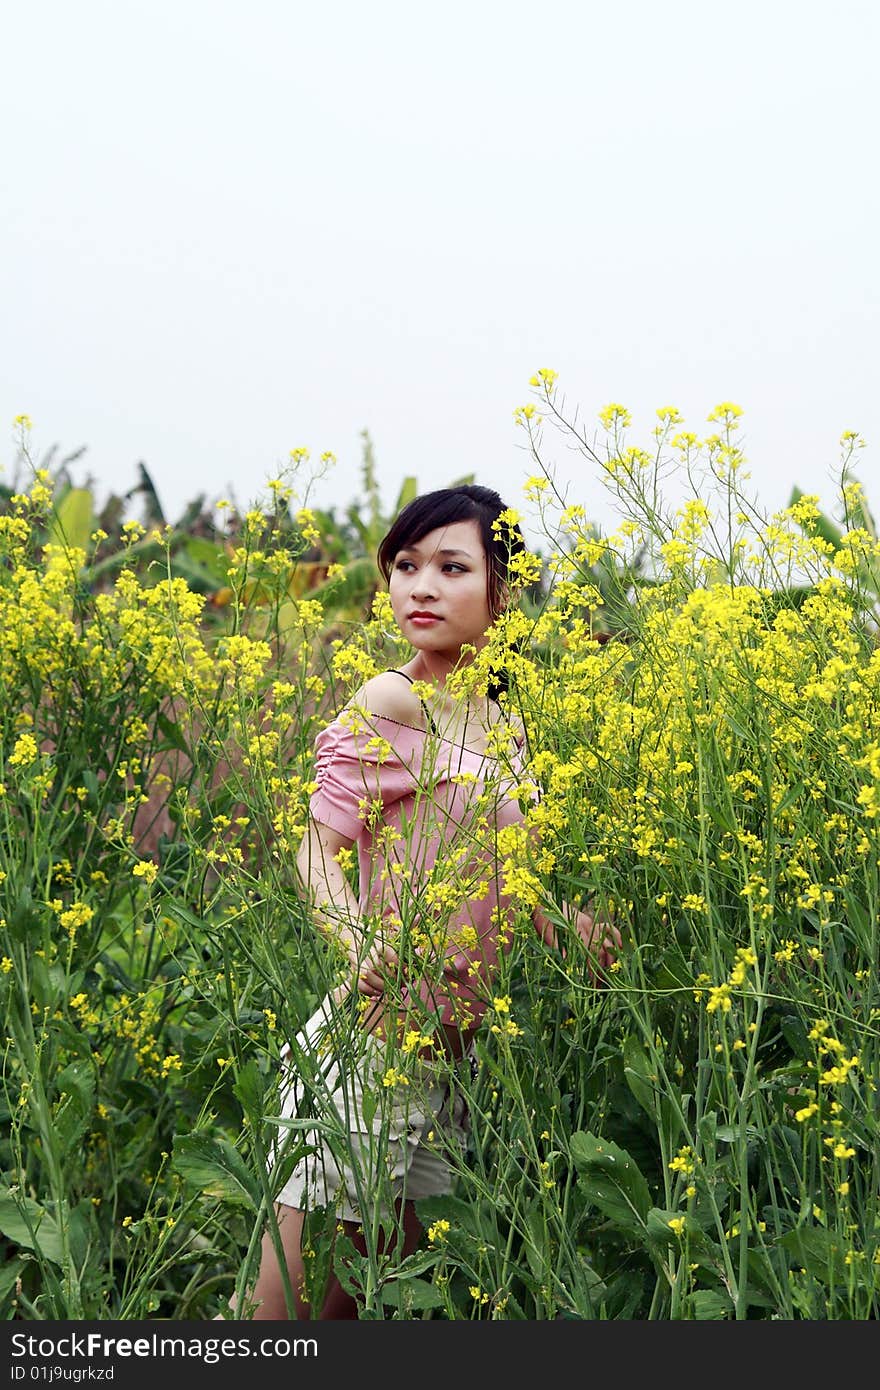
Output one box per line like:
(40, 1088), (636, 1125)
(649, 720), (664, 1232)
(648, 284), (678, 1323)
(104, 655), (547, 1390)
(377, 482), (525, 619)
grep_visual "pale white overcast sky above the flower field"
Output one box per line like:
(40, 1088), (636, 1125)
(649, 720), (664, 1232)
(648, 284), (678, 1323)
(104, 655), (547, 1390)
(0, 0), (880, 550)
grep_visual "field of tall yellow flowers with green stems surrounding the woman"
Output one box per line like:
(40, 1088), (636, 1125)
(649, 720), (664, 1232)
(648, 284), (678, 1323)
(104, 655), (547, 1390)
(0, 386), (880, 1319)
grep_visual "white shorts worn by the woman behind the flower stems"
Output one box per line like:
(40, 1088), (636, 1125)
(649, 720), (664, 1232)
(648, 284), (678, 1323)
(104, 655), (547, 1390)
(270, 995), (471, 1222)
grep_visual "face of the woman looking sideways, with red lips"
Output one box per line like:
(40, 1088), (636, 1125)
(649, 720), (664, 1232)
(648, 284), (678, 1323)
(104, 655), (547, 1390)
(388, 520), (492, 664)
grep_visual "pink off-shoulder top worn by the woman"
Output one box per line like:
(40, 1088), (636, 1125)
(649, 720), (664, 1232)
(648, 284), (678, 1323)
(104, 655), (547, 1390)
(309, 710), (524, 1031)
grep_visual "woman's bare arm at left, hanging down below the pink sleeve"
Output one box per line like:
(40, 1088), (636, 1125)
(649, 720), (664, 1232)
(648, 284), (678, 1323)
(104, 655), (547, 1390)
(296, 816), (398, 994)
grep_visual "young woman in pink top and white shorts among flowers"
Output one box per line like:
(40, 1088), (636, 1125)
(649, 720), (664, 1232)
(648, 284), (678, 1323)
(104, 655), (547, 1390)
(219, 485), (620, 1319)
